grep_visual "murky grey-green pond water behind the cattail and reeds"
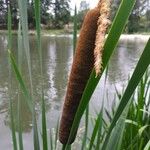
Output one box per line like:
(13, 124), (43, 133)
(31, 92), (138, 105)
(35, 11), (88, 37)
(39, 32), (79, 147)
(0, 35), (146, 150)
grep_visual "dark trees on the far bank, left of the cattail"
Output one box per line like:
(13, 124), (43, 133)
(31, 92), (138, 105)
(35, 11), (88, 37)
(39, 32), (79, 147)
(0, 0), (70, 29)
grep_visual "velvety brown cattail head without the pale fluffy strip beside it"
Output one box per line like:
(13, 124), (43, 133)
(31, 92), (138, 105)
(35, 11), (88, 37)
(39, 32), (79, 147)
(59, 0), (110, 144)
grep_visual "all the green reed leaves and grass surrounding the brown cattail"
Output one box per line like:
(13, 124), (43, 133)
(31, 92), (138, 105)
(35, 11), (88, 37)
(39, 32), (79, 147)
(5, 0), (150, 150)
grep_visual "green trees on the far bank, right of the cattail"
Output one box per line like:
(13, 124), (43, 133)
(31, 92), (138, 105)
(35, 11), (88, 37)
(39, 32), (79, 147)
(113, 0), (150, 33)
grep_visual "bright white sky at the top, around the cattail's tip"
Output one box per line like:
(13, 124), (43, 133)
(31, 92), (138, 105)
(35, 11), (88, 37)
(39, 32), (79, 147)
(71, 0), (99, 8)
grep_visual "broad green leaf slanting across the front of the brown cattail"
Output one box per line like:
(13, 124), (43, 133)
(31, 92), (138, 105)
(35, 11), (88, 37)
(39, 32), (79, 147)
(68, 0), (135, 146)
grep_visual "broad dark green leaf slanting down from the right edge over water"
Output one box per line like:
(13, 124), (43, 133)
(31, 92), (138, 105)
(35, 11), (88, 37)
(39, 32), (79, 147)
(103, 39), (150, 150)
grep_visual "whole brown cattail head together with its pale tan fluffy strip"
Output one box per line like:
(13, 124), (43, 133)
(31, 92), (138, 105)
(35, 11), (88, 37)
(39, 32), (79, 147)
(59, 0), (110, 144)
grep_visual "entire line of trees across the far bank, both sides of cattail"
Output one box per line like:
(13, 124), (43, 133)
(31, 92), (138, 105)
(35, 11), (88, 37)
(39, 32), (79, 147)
(0, 0), (150, 33)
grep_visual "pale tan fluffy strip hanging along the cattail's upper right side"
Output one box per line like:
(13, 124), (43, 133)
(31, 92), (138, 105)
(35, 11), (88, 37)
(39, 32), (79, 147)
(94, 0), (111, 77)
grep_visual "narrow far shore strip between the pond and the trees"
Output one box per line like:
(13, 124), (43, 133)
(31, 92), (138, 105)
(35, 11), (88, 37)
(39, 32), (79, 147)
(0, 29), (150, 41)
